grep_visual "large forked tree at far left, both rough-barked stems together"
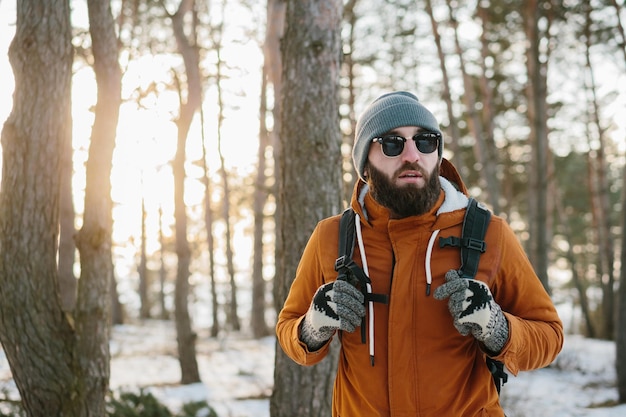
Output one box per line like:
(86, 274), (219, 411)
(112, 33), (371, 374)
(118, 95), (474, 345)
(0, 1), (121, 416)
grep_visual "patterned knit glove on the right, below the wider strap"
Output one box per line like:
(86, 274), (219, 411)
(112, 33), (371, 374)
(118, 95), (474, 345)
(434, 269), (509, 354)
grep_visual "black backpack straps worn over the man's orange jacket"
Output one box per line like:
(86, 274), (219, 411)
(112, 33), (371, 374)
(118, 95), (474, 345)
(335, 198), (508, 394)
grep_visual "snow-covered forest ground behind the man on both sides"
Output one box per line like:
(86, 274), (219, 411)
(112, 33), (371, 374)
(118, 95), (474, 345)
(0, 321), (626, 417)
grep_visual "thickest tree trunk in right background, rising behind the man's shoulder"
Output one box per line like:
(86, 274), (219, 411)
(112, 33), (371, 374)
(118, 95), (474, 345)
(522, 0), (550, 292)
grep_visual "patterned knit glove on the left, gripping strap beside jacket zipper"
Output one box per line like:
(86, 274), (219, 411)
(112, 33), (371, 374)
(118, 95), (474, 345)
(300, 281), (365, 351)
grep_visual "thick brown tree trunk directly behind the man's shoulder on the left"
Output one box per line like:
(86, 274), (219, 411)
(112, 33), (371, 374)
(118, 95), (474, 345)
(270, 0), (342, 417)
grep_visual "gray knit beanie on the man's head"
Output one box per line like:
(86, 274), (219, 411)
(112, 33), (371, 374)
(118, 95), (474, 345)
(352, 91), (443, 180)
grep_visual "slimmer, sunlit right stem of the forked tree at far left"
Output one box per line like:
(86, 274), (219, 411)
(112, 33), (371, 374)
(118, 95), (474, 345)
(75, 0), (122, 416)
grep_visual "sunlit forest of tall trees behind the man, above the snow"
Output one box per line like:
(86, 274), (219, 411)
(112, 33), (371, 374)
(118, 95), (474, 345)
(0, 0), (626, 416)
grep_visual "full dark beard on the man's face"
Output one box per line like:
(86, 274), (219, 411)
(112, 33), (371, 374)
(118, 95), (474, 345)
(367, 163), (441, 219)
